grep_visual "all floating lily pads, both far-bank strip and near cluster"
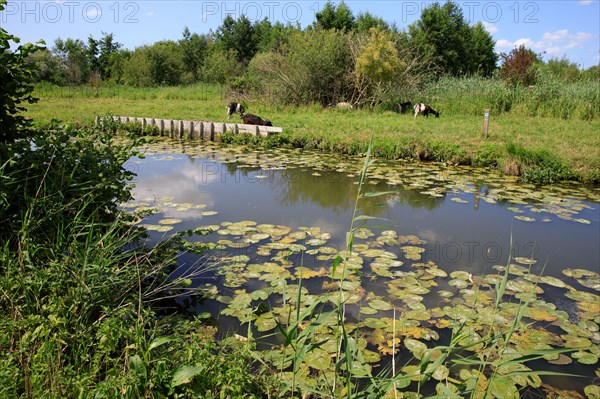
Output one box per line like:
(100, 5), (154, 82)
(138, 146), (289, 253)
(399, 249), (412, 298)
(125, 141), (600, 397)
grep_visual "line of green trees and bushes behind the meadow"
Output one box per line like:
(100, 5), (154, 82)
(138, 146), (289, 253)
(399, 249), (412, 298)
(25, 1), (599, 105)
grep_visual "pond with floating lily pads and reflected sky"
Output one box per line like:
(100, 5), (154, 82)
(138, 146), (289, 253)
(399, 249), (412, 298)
(124, 139), (600, 393)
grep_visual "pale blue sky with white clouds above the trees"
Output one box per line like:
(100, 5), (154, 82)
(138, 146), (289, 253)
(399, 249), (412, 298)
(0, 0), (600, 68)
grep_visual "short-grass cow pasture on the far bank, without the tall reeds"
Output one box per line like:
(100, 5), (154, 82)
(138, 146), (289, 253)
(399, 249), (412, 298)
(27, 85), (600, 182)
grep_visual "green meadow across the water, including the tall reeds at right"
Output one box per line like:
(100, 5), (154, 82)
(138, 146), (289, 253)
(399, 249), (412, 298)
(27, 79), (600, 183)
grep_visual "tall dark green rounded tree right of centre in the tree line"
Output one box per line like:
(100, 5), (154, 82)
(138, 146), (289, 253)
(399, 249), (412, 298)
(408, 1), (497, 76)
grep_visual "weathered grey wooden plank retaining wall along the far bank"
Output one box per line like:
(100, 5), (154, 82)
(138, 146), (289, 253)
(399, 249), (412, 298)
(95, 116), (283, 141)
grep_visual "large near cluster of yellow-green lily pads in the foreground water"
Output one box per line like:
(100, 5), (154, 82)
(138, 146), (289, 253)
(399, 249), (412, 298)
(177, 217), (600, 398)
